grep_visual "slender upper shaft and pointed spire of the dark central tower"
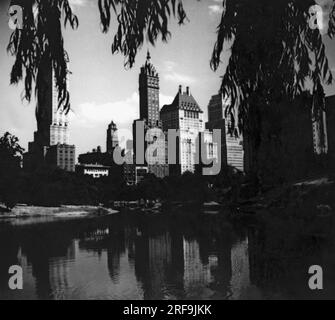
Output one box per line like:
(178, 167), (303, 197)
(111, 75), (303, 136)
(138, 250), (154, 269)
(139, 51), (160, 127)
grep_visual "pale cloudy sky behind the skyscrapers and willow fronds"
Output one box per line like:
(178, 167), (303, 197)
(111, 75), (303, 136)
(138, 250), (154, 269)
(0, 0), (335, 158)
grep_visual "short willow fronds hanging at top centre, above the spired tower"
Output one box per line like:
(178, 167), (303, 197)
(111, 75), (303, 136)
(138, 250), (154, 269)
(99, 0), (187, 68)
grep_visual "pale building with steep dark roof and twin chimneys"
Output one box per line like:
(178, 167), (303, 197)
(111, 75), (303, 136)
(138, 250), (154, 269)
(160, 86), (205, 174)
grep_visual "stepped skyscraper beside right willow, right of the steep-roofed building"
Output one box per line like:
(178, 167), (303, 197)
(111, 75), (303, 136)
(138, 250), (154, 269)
(206, 93), (245, 172)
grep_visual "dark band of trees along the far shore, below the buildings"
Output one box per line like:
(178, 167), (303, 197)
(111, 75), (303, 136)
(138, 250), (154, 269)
(0, 133), (335, 214)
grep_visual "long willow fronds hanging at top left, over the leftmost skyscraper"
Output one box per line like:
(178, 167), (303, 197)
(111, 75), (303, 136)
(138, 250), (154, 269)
(7, 0), (78, 111)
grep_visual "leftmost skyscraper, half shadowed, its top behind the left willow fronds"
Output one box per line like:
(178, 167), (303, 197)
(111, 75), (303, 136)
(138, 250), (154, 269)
(24, 61), (75, 171)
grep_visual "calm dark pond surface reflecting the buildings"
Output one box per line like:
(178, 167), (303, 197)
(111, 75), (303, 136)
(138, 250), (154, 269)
(0, 213), (335, 299)
